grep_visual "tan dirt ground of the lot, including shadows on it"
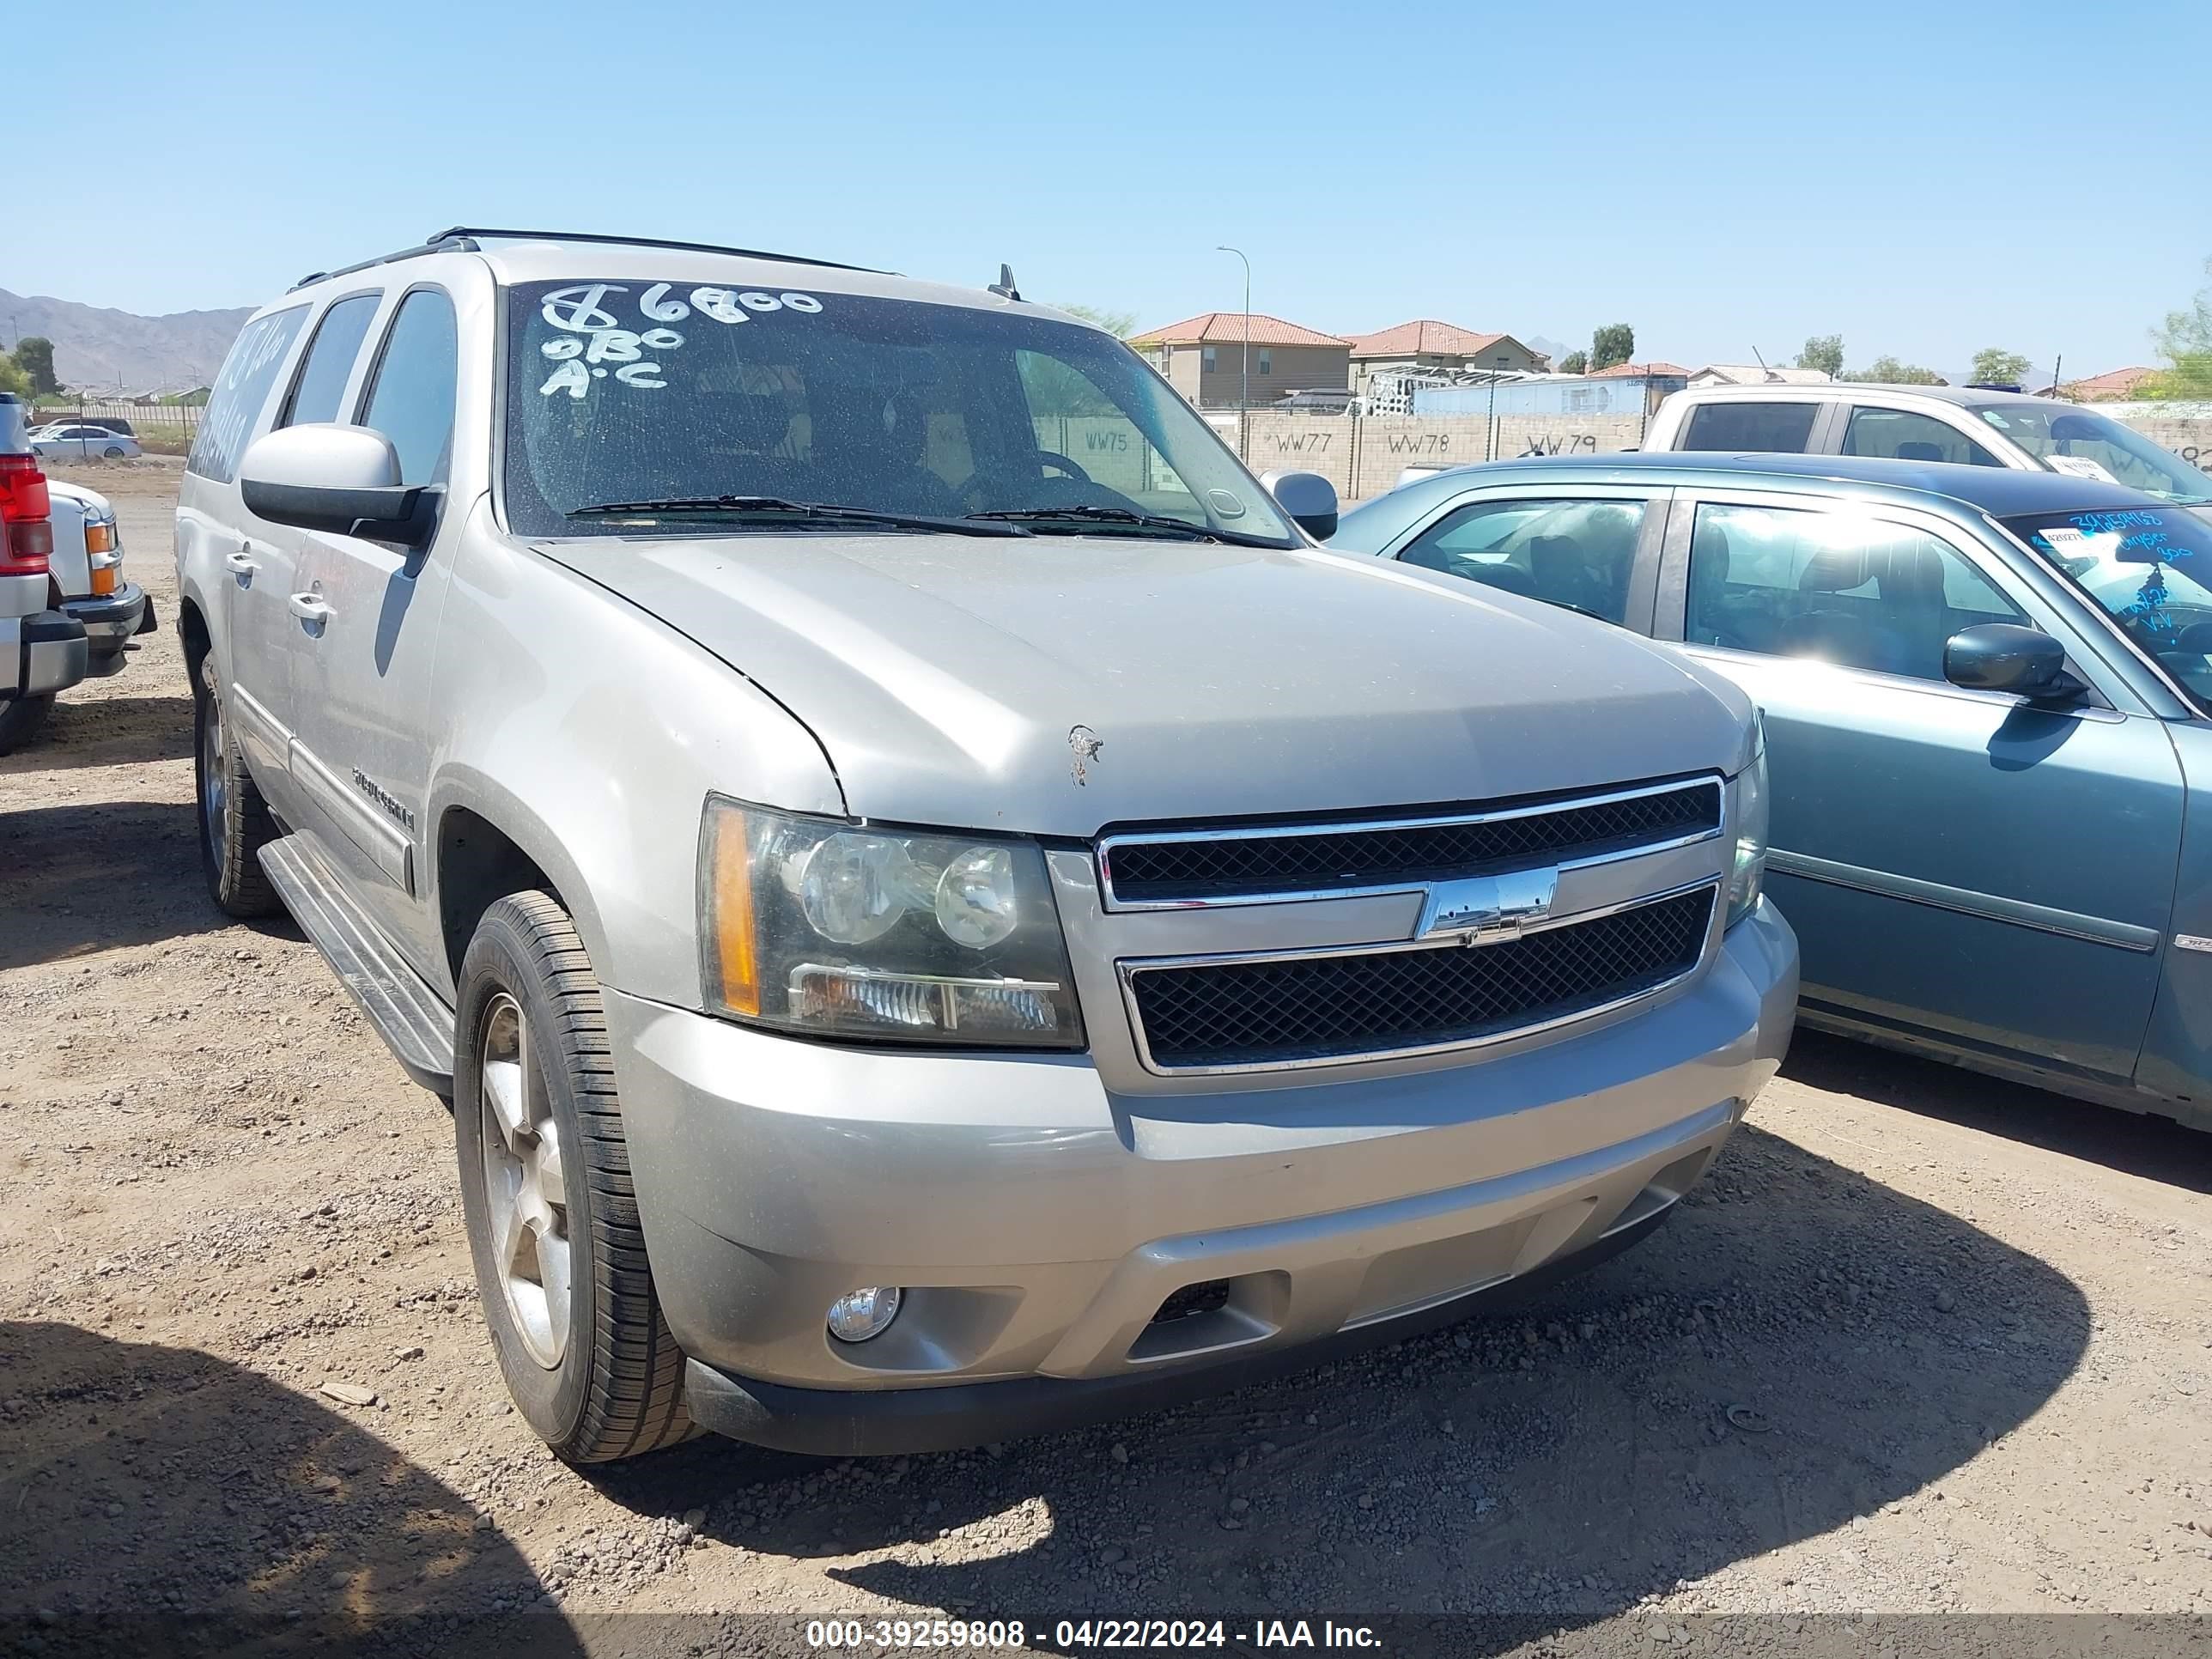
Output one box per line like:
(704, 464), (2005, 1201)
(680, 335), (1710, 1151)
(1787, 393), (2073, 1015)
(13, 462), (2212, 1652)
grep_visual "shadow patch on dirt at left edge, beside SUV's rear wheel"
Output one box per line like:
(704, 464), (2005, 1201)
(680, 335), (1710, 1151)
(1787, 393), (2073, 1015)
(0, 800), (230, 969)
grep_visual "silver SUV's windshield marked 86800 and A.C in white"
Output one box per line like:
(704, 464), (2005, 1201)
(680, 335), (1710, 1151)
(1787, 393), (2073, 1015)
(507, 279), (1297, 546)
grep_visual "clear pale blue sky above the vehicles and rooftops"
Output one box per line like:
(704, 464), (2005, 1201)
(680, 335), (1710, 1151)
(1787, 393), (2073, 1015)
(17, 0), (2212, 374)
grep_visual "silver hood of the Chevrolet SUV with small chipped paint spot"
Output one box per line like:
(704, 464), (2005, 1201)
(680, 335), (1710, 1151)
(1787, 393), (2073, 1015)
(538, 533), (1750, 836)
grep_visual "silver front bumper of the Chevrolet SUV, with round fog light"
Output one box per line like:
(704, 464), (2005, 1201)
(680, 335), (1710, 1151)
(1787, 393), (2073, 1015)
(606, 905), (1796, 1451)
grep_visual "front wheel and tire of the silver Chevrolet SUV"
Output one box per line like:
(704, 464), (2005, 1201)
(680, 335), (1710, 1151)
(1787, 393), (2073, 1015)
(453, 891), (692, 1464)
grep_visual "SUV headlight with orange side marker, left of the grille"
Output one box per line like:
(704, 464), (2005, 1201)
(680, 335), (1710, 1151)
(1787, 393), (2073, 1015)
(699, 796), (1084, 1048)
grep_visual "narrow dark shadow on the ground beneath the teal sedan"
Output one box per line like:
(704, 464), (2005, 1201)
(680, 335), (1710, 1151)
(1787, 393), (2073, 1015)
(1783, 1026), (2212, 1192)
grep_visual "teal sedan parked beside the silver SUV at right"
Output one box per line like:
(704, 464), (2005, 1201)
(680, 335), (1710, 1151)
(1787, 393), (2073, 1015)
(1329, 453), (2212, 1130)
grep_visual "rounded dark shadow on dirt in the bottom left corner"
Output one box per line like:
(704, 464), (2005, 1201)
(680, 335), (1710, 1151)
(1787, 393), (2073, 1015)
(0, 1321), (584, 1659)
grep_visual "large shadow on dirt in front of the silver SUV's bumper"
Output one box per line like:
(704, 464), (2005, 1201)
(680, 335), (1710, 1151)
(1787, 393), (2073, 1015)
(599, 1128), (2088, 1646)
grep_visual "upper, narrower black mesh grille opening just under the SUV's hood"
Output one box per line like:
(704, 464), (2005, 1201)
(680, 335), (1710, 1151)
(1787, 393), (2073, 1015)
(1099, 779), (1721, 909)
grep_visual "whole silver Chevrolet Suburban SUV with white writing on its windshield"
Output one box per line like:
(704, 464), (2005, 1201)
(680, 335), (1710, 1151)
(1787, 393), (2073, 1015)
(177, 230), (1796, 1462)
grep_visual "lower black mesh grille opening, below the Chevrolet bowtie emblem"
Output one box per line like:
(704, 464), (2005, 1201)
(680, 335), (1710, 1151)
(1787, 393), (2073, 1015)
(1126, 883), (1719, 1071)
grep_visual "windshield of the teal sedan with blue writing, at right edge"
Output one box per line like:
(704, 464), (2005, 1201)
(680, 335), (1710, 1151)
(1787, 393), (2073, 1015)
(2004, 507), (2212, 712)
